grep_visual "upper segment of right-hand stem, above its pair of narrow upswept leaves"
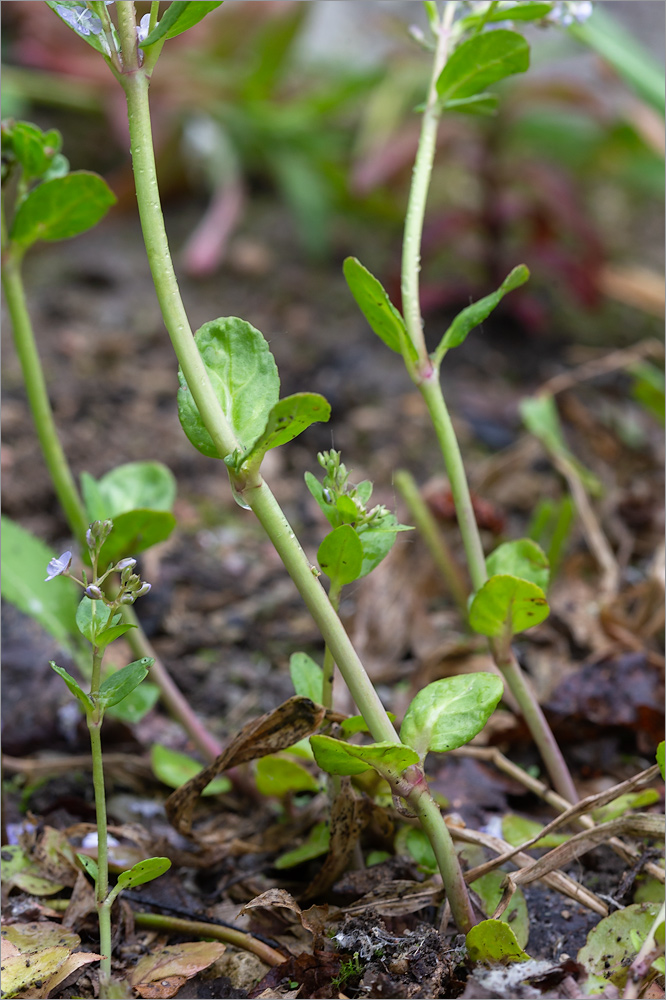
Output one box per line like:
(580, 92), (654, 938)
(400, 0), (455, 364)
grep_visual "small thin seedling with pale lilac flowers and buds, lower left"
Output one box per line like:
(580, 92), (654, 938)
(46, 520), (171, 997)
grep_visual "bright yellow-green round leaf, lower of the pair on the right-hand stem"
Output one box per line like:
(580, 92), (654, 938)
(469, 574), (550, 637)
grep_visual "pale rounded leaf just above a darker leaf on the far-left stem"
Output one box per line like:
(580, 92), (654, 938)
(87, 462), (176, 528)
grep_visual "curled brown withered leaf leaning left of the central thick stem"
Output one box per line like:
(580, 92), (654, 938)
(165, 696), (326, 837)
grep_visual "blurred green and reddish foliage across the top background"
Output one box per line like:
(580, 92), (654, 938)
(2, 0), (664, 343)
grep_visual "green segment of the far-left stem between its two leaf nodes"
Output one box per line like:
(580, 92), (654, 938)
(2, 235), (88, 538)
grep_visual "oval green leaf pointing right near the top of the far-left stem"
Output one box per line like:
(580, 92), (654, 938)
(9, 170), (116, 250)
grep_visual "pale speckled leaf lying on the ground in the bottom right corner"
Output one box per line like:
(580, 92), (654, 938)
(577, 894), (663, 997)
